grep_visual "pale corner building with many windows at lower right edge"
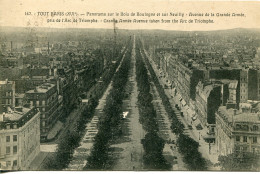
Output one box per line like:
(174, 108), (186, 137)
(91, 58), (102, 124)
(216, 106), (260, 155)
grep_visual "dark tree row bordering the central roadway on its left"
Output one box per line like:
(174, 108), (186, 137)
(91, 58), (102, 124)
(84, 41), (131, 170)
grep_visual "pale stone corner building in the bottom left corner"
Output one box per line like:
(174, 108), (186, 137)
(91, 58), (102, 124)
(0, 107), (40, 170)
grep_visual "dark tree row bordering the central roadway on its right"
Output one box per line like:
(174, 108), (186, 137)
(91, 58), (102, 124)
(135, 41), (170, 170)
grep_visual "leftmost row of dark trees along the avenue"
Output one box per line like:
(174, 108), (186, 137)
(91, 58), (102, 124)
(45, 42), (130, 170)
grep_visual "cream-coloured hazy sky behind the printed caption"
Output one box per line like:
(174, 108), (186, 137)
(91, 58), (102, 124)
(0, 0), (260, 30)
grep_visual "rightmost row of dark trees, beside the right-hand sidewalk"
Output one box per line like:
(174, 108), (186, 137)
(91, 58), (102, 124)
(140, 42), (207, 170)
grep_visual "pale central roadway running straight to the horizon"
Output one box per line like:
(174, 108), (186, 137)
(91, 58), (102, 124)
(112, 35), (145, 170)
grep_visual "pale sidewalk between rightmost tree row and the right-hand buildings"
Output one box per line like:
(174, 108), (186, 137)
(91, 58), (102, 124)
(145, 51), (218, 170)
